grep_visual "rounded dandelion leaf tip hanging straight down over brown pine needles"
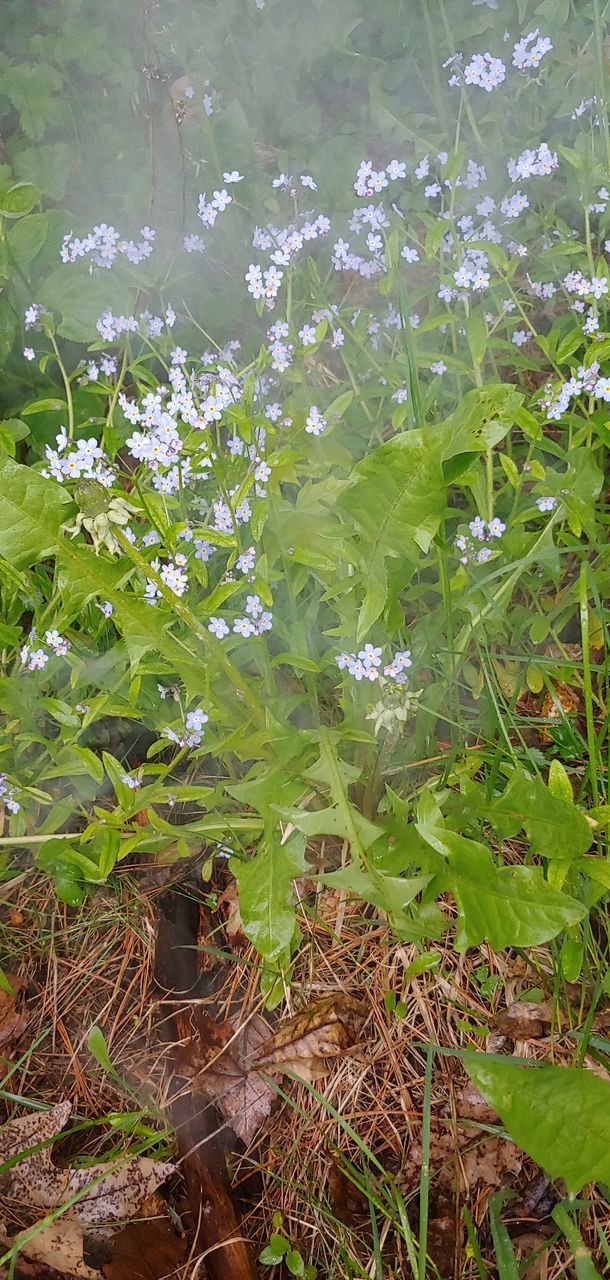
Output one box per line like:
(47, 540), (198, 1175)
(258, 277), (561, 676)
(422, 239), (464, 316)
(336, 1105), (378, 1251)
(230, 835), (308, 960)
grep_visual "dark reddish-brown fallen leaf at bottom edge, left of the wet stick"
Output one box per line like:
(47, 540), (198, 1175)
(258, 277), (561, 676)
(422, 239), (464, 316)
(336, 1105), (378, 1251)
(104, 1216), (185, 1280)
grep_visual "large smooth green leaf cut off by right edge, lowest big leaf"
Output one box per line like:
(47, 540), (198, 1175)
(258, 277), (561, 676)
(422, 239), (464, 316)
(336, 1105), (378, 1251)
(464, 1053), (610, 1194)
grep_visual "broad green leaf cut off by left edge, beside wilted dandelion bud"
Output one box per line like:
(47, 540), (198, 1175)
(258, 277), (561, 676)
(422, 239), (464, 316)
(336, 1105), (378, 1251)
(0, 454), (72, 568)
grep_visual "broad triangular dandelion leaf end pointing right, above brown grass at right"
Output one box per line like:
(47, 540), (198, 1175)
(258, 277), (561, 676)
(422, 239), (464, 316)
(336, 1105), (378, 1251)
(445, 831), (586, 951)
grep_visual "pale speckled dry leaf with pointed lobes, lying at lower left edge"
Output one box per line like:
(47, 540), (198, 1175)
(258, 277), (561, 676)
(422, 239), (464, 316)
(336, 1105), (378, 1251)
(0, 1101), (174, 1225)
